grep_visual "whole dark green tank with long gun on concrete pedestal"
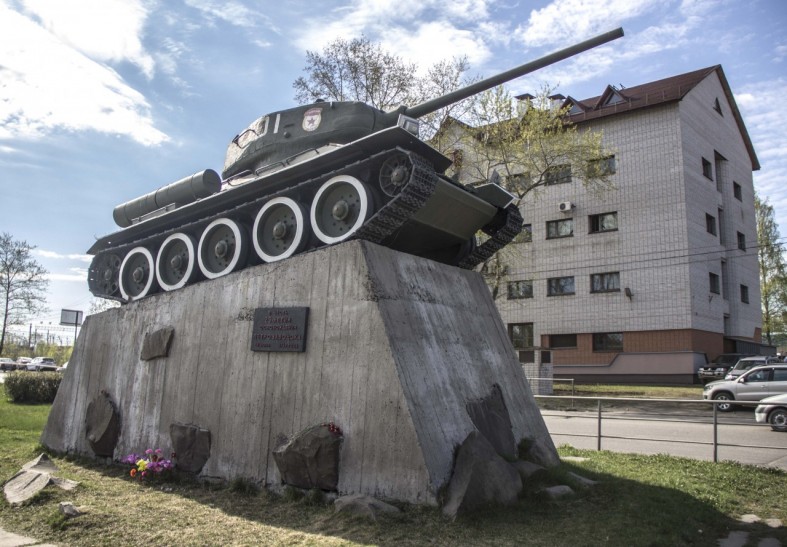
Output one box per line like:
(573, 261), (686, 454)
(88, 29), (623, 302)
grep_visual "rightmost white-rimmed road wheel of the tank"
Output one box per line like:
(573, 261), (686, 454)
(311, 175), (374, 244)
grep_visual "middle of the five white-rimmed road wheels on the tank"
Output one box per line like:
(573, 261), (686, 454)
(197, 218), (249, 279)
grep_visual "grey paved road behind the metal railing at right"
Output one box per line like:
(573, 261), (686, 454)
(542, 409), (787, 471)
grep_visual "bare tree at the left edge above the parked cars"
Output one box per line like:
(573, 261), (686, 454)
(0, 232), (49, 354)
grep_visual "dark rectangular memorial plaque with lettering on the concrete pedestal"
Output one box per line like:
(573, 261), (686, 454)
(251, 308), (309, 351)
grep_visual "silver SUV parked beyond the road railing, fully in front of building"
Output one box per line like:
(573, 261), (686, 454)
(702, 364), (787, 412)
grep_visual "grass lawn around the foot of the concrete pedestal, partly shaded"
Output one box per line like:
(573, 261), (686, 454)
(0, 401), (787, 546)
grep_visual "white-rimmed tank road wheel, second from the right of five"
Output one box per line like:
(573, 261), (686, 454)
(251, 197), (307, 262)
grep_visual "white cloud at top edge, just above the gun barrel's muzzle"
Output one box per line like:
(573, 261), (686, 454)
(516, 0), (664, 46)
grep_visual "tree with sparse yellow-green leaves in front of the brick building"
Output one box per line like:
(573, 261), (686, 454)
(444, 86), (615, 297)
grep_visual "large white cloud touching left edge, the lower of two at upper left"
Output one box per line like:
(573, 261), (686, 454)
(0, 4), (168, 145)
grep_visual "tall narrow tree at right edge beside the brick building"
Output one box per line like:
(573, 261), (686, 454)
(754, 194), (787, 345)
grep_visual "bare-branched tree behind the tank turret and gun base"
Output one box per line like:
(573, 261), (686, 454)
(292, 36), (474, 136)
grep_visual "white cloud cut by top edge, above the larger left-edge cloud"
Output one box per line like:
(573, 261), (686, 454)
(18, 0), (154, 78)
